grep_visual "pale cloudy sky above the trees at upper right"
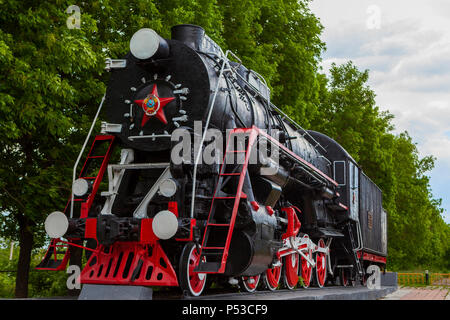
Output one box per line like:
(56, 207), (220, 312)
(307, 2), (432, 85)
(311, 0), (450, 223)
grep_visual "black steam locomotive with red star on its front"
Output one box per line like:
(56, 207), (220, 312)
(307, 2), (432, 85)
(37, 25), (387, 296)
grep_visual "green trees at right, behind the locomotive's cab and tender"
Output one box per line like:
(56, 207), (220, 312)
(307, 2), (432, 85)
(313, 62), (450, 270)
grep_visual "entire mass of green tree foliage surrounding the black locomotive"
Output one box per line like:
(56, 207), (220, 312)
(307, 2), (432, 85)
(0, 0), (450, 296)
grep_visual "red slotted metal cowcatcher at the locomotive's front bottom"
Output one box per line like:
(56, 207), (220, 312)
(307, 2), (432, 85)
(80, 242), (178, 286)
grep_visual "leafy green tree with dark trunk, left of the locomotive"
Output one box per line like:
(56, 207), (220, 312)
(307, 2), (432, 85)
(0, 0), (105, 297)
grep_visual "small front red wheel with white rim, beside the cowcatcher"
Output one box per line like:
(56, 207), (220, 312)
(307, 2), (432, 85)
(178, 242), (206, 297)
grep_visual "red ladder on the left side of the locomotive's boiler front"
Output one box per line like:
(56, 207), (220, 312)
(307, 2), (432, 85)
(64, 135), (115, 218)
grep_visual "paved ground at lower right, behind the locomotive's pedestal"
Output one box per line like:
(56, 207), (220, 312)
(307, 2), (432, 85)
(383, 287), (450, 300)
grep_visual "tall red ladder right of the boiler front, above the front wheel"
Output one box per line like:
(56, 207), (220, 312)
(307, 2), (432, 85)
(195, 129), (258, 273)
